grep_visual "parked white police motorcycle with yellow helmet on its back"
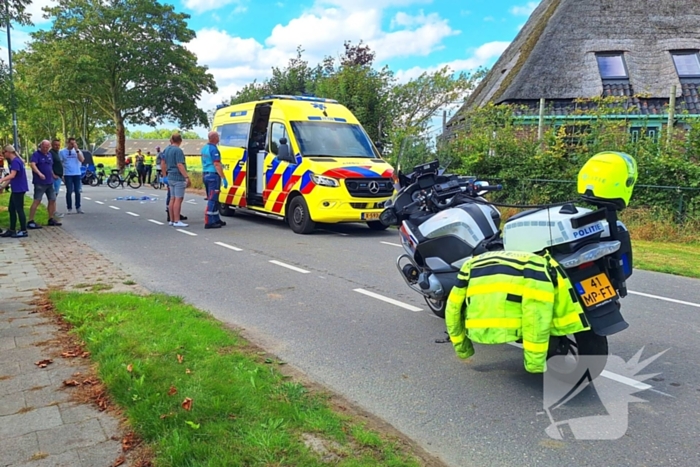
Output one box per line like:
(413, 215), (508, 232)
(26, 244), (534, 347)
(380, 146), (637, 379)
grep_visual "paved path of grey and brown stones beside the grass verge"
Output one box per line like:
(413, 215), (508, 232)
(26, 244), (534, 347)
(0, 227), (145, 467)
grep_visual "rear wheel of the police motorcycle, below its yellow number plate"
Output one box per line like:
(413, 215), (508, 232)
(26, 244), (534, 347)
(547, 331), (609, 384)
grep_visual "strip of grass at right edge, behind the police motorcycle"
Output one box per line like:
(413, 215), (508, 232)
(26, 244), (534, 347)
(632, 240), (700, 279)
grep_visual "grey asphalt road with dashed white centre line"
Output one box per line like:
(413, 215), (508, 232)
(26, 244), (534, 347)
(49, 187), (700, 466)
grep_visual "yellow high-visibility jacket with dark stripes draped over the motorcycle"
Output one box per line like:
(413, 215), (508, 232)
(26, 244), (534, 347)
(445, 251), (588, 373)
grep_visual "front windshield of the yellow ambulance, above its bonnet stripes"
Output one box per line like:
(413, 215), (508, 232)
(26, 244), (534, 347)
(292, 122), (379, 158)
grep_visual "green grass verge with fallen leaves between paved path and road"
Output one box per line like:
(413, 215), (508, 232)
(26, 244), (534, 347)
(51, 292), (420, 467)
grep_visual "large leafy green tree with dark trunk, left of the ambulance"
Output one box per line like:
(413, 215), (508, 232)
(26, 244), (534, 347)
(29, 0), (216, 167)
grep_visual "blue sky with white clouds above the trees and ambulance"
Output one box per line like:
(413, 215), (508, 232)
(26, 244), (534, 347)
(0, 0), (539, 133)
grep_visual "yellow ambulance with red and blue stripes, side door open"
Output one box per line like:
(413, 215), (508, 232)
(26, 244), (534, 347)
(212, 95), (394, 234)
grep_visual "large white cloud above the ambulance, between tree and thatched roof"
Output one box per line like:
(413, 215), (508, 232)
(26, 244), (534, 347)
(184, 0), (459, 109)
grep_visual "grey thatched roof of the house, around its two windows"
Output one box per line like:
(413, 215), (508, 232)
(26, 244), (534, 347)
(448, 0), (700, 128)
